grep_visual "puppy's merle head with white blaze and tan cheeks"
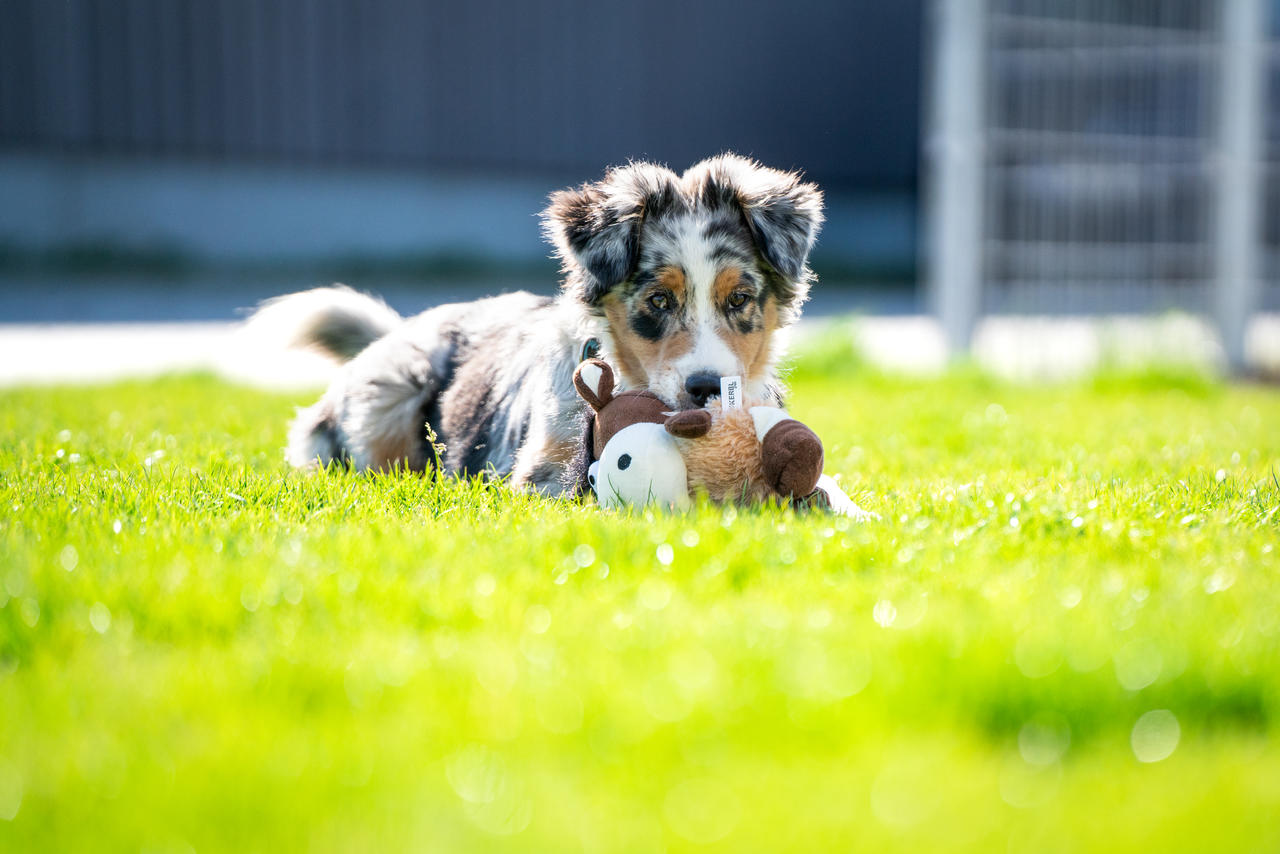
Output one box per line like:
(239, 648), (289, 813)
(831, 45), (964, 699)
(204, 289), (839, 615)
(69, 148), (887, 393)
(544, 155), (822, 408)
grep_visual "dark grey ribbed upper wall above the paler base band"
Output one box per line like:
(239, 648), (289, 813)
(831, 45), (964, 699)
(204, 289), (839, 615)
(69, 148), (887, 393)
(0, 0), (920, 188)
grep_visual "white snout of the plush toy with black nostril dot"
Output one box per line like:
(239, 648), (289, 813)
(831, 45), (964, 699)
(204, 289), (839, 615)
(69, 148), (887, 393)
(588, 423), (690, 507)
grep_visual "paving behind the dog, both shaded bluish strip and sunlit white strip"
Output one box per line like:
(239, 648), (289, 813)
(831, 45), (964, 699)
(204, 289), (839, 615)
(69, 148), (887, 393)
(0, 275), (1280, 388)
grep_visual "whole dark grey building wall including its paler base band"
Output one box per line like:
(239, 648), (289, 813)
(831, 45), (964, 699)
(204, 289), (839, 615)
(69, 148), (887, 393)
(0, 0), (920, 274)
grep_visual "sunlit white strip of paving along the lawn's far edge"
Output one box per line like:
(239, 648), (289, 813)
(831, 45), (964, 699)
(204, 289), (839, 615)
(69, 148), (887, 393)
(0, 315), (1280, 388)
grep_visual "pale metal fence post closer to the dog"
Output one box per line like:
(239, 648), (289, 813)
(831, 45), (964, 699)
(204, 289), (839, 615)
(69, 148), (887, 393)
(925, 0), (987, 353)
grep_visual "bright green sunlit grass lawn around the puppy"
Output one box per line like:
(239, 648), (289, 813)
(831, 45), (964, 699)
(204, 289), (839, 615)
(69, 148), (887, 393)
(0, 347), (1280, 851)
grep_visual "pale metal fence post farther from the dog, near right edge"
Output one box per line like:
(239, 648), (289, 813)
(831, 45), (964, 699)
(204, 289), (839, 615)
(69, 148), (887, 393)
(1213, 0), (1267, 371)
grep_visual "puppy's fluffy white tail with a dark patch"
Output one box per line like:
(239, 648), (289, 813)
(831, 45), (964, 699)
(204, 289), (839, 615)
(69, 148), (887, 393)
(241, 284), (403, 362)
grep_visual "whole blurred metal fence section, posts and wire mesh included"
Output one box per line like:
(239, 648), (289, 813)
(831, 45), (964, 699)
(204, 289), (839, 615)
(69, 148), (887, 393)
(925, 0), (1280, 366)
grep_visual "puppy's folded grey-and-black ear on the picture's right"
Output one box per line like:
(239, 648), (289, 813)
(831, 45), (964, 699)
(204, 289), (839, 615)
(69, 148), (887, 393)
(685, 154), (823, 302)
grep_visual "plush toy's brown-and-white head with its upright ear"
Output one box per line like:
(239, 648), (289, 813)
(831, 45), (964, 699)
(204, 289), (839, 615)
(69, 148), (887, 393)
(573, 359), (689, 507)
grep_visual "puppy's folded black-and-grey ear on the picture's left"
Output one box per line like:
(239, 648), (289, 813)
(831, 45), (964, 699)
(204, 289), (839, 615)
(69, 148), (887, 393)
(543, 163), (680, 305)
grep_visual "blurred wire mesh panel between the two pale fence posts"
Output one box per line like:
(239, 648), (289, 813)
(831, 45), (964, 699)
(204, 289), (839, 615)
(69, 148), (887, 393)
(982, 0), (1220, 312)
